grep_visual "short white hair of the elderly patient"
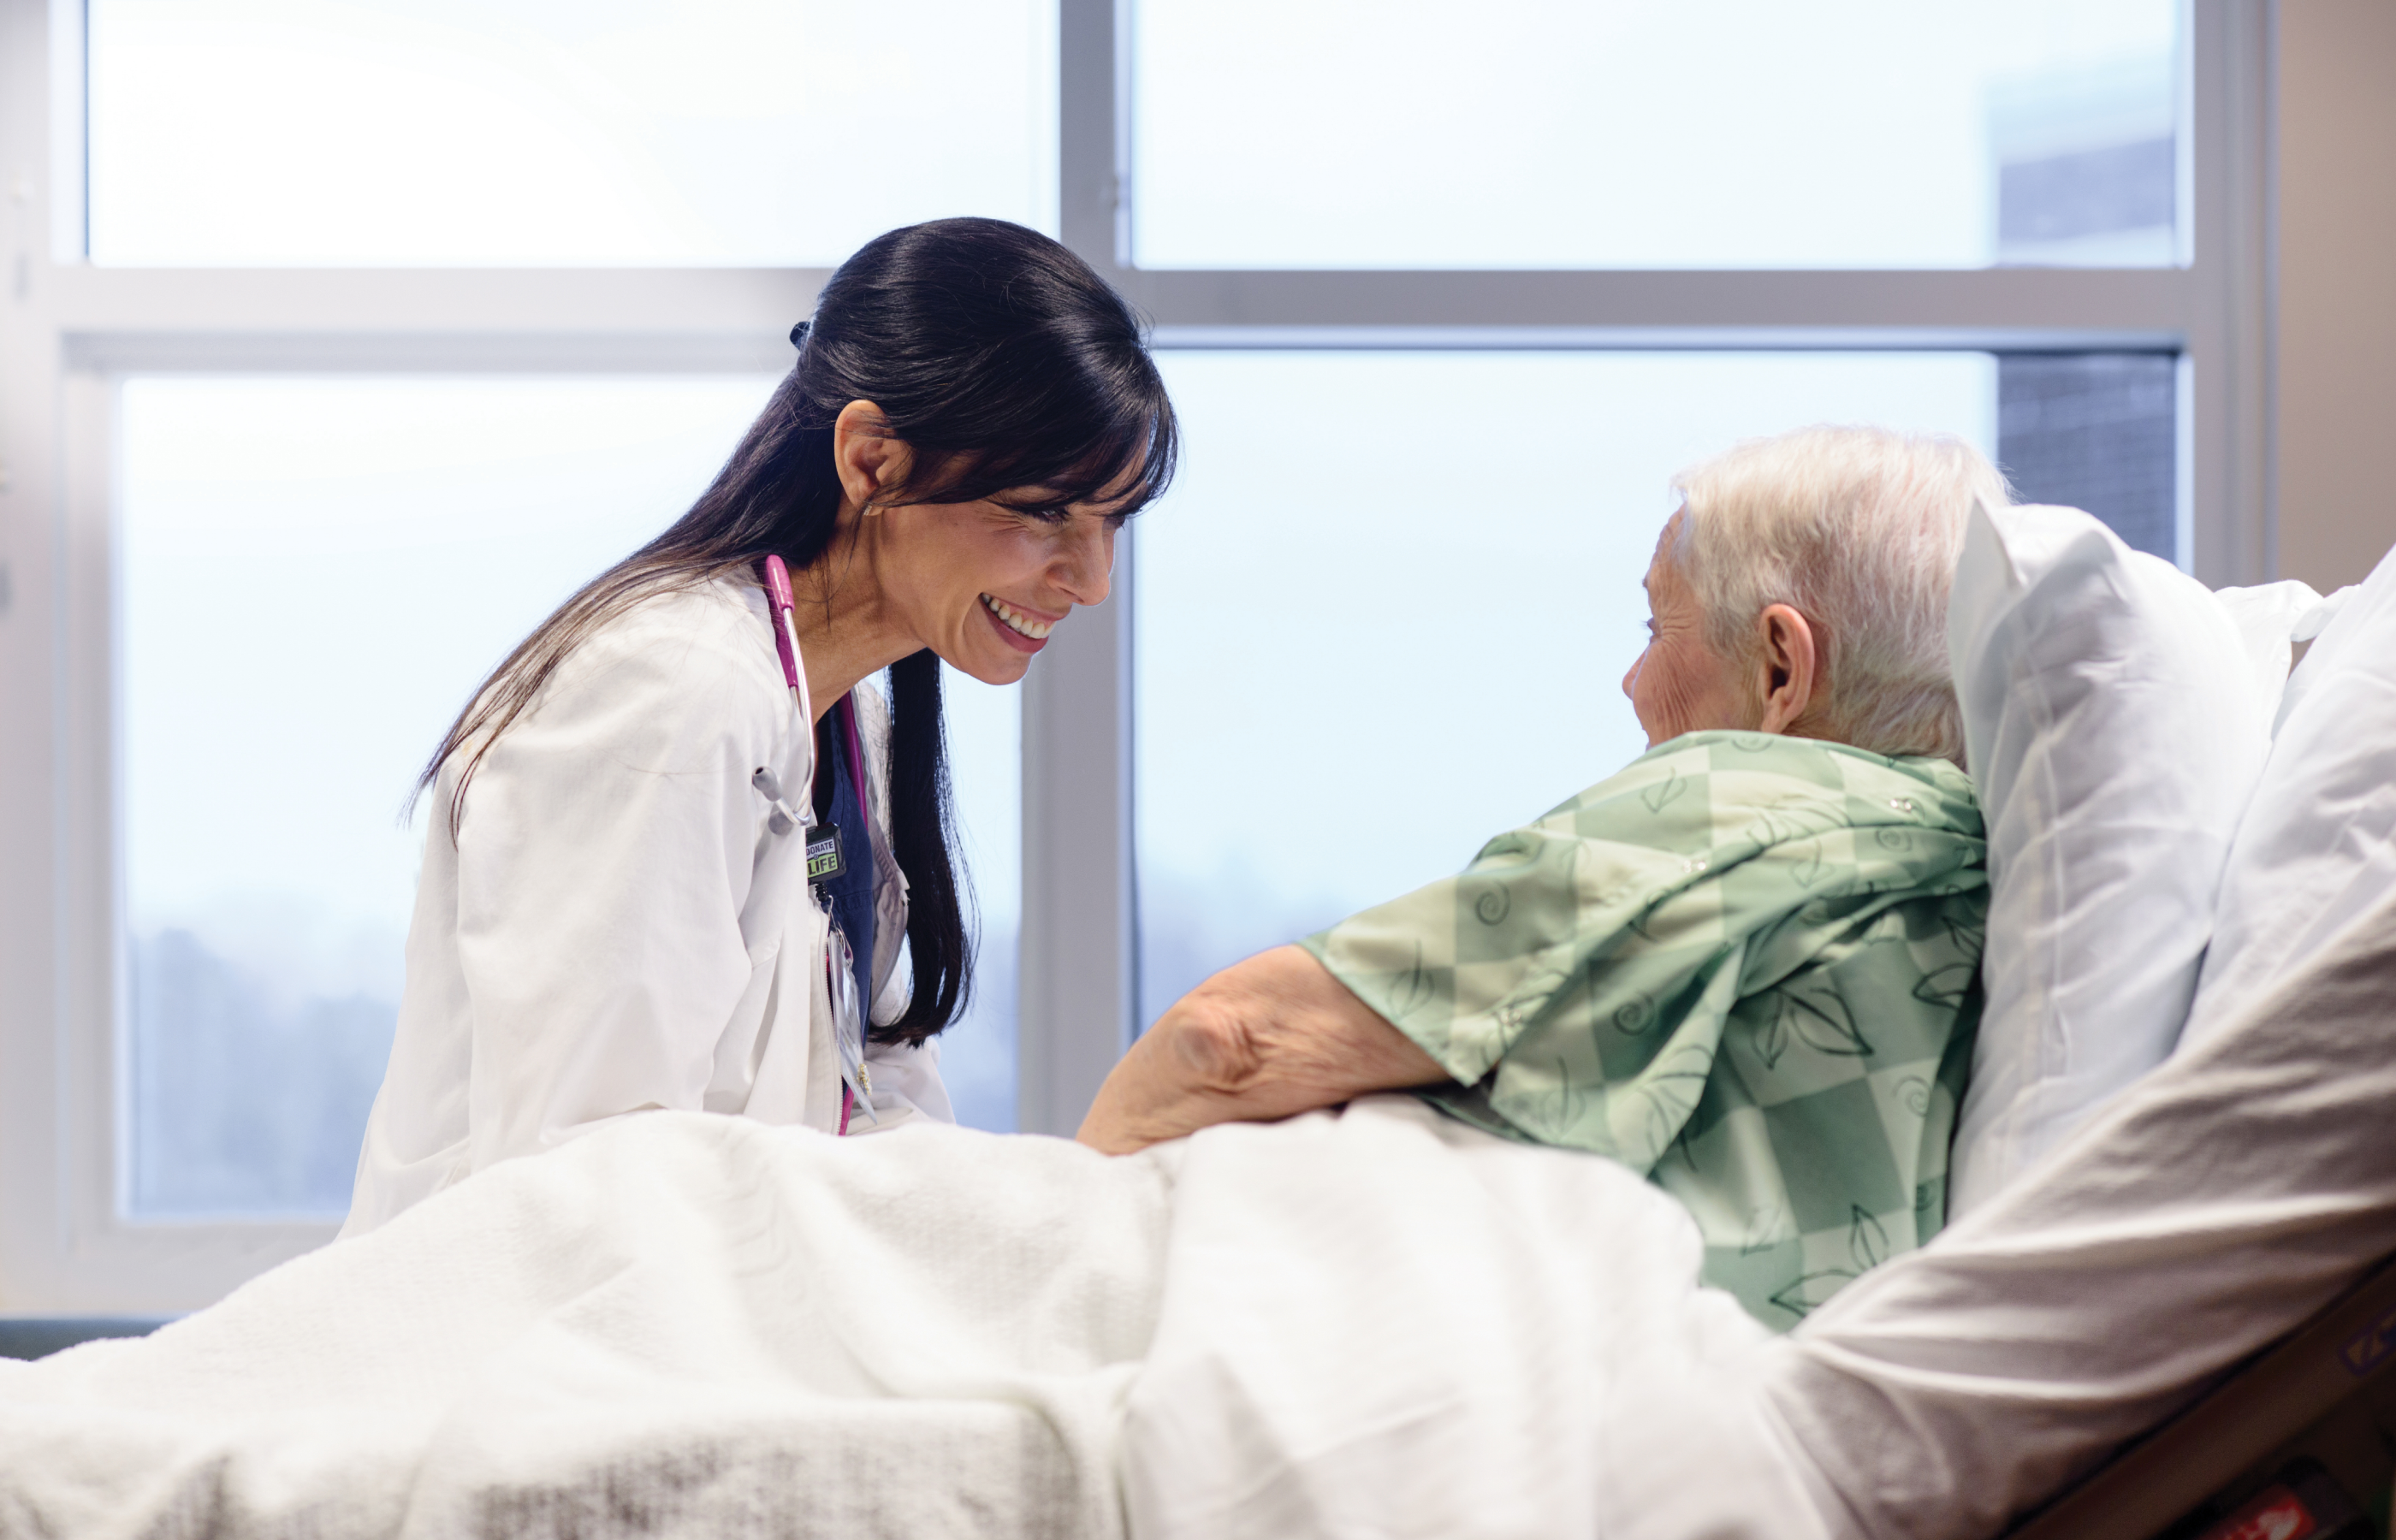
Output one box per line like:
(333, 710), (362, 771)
(1672, 426), (2008, 764)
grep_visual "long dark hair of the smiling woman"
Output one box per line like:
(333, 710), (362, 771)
(417, 218), (1177, 1042)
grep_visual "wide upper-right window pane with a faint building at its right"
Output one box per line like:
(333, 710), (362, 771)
(1133, 0), (2183, 269)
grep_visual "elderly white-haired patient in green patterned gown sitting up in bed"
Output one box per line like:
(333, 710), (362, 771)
(1081, 429), (2006, 1330)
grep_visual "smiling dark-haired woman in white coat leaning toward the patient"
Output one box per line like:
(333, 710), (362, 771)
(345, 221), (1174, 1234)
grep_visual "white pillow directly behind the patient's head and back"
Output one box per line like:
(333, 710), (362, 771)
(1948, 507), (2269, 1217)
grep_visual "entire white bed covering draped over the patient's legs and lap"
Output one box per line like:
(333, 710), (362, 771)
(0, 1097), (1802, 1540)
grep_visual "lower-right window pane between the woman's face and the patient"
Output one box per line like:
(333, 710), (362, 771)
(1131, 352), (1996, 1025)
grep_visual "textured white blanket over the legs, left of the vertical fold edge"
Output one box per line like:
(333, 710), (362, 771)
(0, 1114), (1167, 1537)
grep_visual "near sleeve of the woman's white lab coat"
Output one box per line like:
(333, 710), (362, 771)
(458, 596), (796, 1171)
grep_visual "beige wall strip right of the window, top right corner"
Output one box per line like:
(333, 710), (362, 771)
(2279, 0), (2396, 591)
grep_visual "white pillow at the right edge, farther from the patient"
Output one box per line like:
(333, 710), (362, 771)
(2185, 536), (2396, 1042)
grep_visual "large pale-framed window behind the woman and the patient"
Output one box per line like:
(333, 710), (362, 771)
(0, 0), (2269, 1310)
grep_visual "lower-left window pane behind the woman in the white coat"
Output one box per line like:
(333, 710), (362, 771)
(117, 378), (1018, 1214)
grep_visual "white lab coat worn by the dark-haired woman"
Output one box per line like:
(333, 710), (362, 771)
(342, 578), (953, 1235)
